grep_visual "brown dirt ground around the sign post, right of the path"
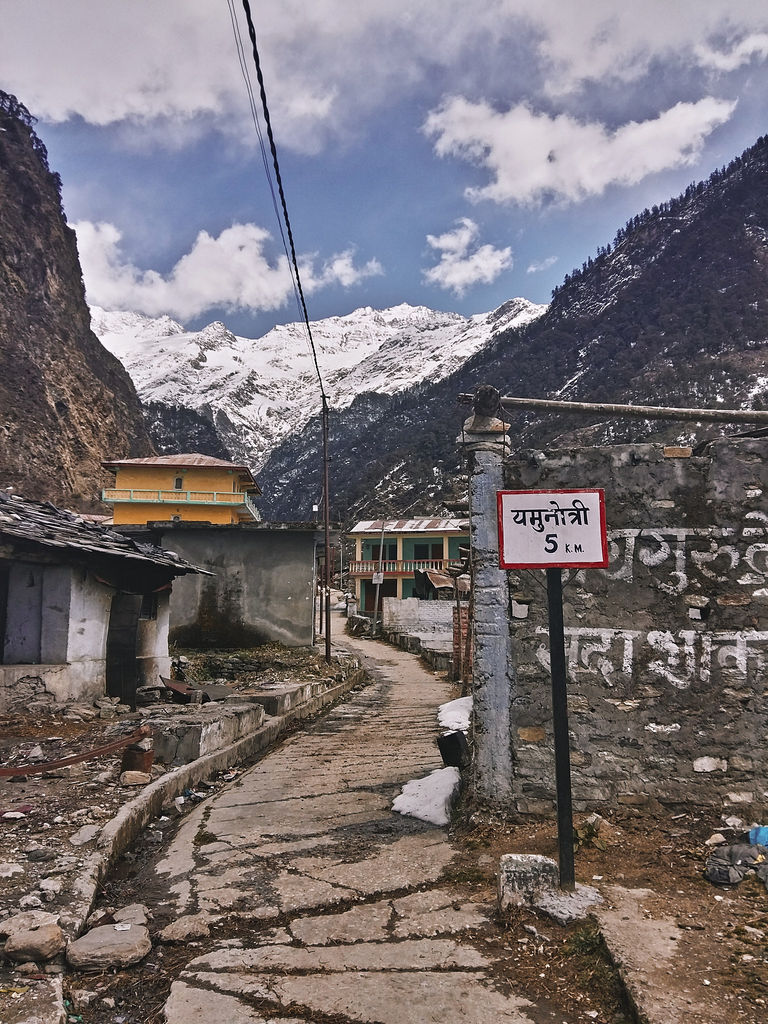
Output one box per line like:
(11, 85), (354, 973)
(454, 809), (768, 1024)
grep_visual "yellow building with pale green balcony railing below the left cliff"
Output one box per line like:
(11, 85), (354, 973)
(101, 453), (261, 526)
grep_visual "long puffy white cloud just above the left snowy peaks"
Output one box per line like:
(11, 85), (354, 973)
(73, 221), (382, 319)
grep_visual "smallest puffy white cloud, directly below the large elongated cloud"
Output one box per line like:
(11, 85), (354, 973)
(424, 217), (512, 298)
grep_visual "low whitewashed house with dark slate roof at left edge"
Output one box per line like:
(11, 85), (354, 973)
(0, 492), (199, 710)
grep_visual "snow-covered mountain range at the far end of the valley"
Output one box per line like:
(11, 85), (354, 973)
(91, 299), (547, 470)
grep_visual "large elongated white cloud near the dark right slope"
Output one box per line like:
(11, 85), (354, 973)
(424, 96), (736, 205)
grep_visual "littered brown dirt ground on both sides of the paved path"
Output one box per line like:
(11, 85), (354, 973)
(0, 645), (768, 1024)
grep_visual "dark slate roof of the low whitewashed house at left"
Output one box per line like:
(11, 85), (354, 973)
(0, 490), (205, 575)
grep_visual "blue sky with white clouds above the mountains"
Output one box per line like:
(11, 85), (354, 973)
(0, 0), (768, 337)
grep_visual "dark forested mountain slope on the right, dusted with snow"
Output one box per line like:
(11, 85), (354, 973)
(261, 137), (768, 518)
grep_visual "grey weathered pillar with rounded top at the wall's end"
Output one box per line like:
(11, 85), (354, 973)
(459, 392), (514, 808)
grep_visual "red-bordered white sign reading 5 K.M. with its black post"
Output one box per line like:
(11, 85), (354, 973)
(497, 489), (608, 892)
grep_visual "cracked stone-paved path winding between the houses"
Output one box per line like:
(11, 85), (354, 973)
(145, 637), (539, 1024)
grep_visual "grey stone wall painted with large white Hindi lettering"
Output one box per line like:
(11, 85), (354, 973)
(501, 438), (768, 819)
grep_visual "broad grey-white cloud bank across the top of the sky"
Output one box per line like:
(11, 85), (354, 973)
(0, 0), (768, 152)
